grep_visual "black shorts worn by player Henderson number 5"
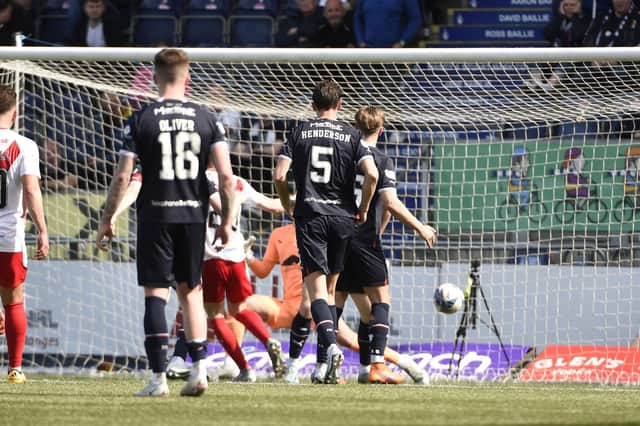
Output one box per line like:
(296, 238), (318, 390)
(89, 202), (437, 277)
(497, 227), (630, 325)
(295, 216), (356, 276)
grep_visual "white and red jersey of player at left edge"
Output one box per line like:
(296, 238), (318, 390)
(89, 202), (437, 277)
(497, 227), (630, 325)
(0, 129), (40, 253)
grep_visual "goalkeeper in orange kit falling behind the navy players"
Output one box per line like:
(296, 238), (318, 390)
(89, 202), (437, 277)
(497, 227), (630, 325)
(242, 224), (426, 384)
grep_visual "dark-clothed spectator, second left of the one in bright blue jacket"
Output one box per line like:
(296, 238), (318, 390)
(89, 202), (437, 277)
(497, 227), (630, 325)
(276, 0), (324, 47)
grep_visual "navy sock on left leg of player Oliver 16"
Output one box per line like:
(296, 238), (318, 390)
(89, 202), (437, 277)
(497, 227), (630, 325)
(144, 296), (169, 373)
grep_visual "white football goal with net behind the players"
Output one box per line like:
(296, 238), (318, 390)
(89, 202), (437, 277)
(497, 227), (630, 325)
(0, 47), (640, 383)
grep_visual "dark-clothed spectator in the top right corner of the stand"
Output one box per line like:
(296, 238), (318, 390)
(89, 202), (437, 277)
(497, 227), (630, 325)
(584, 0), (640, 47)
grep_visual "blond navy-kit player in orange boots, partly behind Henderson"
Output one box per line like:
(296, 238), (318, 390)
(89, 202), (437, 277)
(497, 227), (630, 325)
(336, 106), (436, 384)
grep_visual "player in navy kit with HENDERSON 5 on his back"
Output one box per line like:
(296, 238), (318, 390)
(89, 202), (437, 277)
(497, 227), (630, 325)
(274, 80), (378, 383)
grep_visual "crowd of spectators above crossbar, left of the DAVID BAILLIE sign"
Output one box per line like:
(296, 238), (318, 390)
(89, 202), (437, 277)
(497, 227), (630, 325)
(0, 0), (431, 47)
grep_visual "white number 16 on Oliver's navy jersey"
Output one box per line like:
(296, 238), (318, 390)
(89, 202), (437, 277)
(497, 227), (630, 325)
(158, 132), (201, 180)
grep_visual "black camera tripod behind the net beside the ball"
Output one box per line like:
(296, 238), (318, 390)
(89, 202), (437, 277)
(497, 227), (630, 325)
(448, 260), (511, 378)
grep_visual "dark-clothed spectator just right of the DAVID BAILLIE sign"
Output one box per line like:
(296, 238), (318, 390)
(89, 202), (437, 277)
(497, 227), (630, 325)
(544, 0), (591, 47)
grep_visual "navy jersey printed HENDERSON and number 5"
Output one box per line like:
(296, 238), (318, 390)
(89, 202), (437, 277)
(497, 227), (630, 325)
(280, 118), (371, 218)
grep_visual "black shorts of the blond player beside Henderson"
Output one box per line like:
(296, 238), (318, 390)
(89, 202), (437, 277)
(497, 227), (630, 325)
(336, 239), (389, 293)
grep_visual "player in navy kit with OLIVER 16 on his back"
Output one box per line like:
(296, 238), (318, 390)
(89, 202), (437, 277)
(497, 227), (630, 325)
(97, 49), (233, 396)
